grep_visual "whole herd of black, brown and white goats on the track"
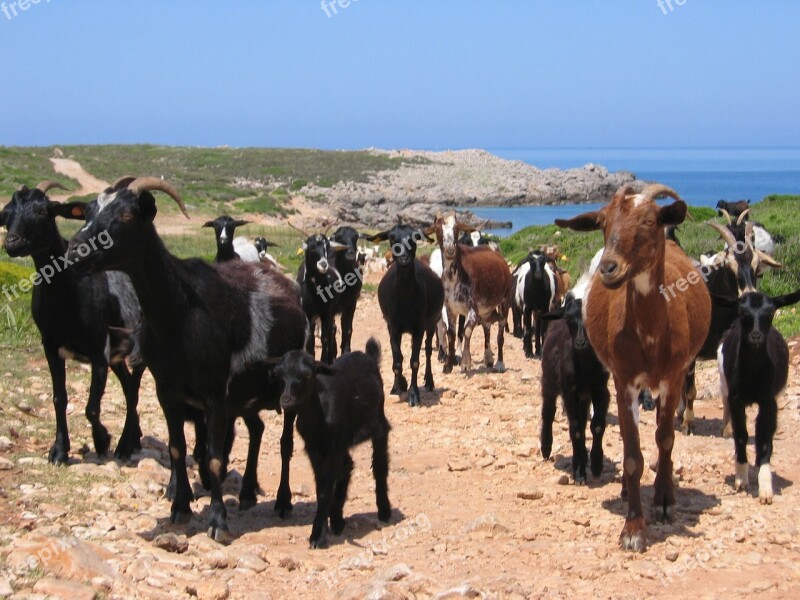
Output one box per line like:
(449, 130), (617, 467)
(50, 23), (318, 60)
(0, 177), (800, 551)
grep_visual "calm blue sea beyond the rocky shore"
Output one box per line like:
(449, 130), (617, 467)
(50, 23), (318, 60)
(473, 148), (800, 236)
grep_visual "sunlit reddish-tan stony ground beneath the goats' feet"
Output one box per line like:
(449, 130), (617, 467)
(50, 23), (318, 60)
(0, 274), (800, 600)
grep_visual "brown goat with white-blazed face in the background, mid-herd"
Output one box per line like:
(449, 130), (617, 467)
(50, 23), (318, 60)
(427, 213), (511, 373)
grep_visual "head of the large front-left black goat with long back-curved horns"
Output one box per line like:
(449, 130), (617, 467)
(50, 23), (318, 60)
(69, 177), (189, 271)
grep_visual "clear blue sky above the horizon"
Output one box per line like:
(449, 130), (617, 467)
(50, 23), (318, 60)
(0, 0), (800, 148)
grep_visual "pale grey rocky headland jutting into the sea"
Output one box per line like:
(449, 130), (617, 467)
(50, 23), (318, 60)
(302, 150), (643, 227)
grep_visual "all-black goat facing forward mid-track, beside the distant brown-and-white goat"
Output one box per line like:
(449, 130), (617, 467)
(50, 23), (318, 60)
(367, 225), (444, 406)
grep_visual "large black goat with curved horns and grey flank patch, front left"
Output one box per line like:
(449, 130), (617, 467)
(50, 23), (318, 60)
(68, 177), (306, 542)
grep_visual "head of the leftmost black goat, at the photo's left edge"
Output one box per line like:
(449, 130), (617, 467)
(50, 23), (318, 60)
(0, 181), (86, 257)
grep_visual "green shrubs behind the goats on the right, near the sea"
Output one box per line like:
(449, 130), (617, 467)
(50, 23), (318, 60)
(500, 196), (800, 337)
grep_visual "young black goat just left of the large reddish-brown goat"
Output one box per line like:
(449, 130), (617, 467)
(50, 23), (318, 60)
(541, 294), (610, 485)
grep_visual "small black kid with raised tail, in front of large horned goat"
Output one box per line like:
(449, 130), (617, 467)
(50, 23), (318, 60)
(266, 338), (392, 548)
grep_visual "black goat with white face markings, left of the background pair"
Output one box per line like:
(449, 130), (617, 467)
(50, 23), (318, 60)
(297, 234), (347, 364)
